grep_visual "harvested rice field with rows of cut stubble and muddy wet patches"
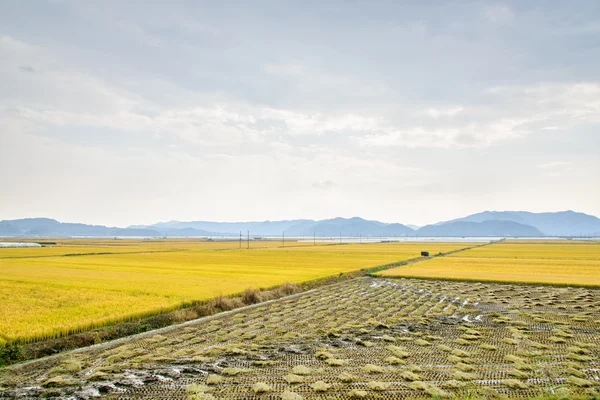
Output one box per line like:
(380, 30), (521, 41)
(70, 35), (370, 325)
(0, 277), (600, 400)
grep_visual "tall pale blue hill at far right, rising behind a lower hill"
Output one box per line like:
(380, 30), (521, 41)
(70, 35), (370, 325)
(438, 211), (600, 236)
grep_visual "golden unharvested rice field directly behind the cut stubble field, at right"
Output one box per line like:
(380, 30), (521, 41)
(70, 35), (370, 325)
(379, 242), (600, 287)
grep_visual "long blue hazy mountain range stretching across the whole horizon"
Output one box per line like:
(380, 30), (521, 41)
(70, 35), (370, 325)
(0, 211), (600, 237)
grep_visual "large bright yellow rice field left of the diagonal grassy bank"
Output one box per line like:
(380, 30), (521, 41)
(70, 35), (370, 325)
(0, 240), (469, 342)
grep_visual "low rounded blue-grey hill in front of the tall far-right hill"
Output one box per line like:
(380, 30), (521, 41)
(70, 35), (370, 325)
(417, 221), (544, 236)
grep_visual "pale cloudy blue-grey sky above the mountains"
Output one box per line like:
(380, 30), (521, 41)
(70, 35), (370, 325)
(0, 0), (600, 226)
